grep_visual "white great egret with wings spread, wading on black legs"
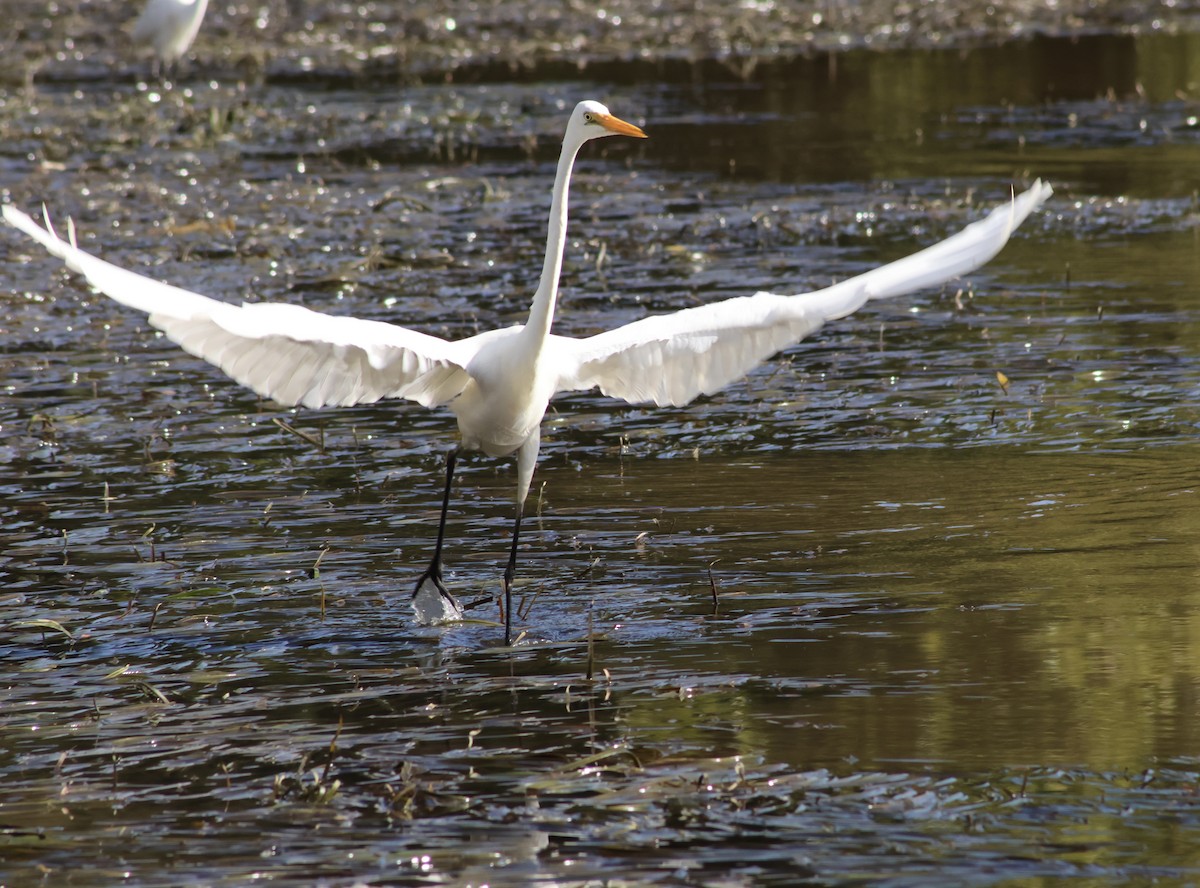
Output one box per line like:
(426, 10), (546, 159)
(4, 101), (1051, 644)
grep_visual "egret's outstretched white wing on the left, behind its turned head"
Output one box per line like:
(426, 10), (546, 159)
(4, 206), (480, 407)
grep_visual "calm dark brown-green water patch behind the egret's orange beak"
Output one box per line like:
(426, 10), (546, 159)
(628, 34), (1200, 197)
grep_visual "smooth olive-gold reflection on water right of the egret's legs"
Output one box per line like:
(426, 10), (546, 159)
(547, 450), (1200, 769)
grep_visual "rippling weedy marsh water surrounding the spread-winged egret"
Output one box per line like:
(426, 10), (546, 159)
(0, 5), (1200, 884)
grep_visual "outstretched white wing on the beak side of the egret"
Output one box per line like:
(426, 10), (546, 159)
(554, 180), (1052, 406)
